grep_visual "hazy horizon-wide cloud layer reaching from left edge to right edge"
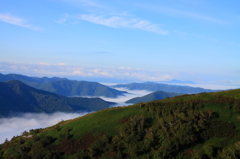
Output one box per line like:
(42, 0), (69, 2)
(0, 62), (240, 89)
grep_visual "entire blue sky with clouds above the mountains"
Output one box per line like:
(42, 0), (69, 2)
(0, 0), (240, 85)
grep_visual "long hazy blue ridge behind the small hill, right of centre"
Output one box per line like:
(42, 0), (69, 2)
(113, 82), (220, 94)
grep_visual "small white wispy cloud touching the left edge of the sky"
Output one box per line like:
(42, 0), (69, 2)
(0, 14), (41, 31)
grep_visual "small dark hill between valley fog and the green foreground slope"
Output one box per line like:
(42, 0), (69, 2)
(126, 91), (182, 104)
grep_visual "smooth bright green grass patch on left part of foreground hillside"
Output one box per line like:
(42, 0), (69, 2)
(42, 105), (151, 139)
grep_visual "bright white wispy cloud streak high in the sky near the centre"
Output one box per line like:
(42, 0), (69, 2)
(78, 13), (168, 35)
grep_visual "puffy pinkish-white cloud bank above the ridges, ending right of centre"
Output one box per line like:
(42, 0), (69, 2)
(0, 62), (172, 81)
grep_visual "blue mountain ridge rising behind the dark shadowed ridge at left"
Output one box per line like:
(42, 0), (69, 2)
(0, 74), (127, 98)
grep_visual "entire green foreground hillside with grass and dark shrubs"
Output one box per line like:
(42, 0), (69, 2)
(0, 89), (240, 159)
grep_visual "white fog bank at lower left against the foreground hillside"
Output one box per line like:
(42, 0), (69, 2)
(0, 112), (87, 144)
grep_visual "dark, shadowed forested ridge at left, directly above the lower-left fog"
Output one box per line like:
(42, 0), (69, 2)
(0, 80), (115, 117)
